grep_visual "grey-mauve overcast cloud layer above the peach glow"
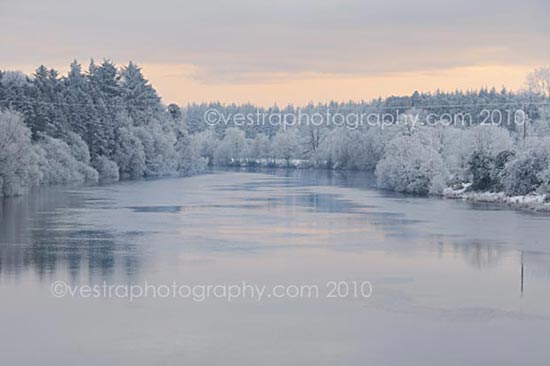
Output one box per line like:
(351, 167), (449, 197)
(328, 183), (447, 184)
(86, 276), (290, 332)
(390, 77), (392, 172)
(0, 0), (550, 103)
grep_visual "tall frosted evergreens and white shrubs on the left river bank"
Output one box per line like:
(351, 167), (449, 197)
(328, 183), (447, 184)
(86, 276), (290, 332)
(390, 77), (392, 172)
(0, 60), (205, 196)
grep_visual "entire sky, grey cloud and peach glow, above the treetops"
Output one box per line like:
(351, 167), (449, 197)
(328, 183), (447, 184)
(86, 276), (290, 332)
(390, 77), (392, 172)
(0, 0), (550, 106)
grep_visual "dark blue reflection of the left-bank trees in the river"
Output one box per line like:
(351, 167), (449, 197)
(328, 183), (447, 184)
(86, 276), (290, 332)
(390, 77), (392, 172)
(0, 188), (141, 281)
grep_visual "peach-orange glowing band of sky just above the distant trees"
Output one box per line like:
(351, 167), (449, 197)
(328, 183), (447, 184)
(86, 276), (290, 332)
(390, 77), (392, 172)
(142, 64), (530, 106)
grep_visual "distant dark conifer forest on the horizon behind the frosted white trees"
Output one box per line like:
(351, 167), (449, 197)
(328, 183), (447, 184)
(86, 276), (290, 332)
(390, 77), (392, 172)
(184, 88), (549, 137)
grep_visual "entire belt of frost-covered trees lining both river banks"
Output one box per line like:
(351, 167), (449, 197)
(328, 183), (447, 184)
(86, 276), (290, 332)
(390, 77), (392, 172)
(0, 61), (550, 196)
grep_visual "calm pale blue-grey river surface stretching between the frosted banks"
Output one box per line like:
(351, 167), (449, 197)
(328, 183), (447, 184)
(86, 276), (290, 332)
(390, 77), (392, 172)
(0, 170), (550, 366)
